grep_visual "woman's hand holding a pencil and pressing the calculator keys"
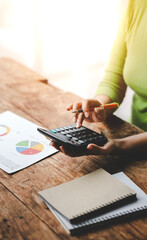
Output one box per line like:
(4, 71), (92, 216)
(67, 99), (106, 128)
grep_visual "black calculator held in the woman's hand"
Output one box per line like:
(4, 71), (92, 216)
(37, 124), (108, 153)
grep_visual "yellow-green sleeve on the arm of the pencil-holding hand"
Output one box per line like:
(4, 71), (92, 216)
(95, 12), (126, 103)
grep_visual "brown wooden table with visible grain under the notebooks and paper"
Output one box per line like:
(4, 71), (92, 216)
(0, 58), (147, 240)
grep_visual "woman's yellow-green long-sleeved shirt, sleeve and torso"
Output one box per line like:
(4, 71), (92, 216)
(96, 0), (147, 131)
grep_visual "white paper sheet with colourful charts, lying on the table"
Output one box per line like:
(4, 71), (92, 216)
(0, 111), (57, 173)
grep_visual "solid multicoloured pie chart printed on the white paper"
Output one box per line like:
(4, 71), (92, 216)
(16, 140), (44, 155)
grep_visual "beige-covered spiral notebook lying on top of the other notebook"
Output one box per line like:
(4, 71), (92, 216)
(39, 169), (136, 222)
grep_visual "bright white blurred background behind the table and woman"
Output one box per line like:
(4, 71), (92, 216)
(0, 0), (133, 121)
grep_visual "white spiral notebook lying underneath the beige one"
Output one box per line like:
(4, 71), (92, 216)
(47, 172), (147, 235)
